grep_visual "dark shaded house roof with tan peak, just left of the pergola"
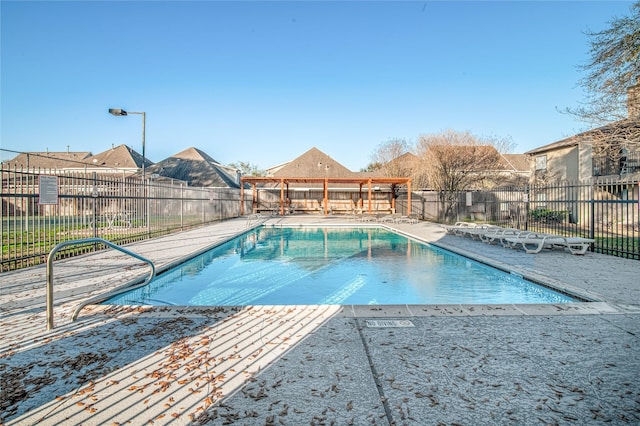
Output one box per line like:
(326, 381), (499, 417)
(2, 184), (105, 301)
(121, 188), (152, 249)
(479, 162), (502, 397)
(147, 147), (240, 188)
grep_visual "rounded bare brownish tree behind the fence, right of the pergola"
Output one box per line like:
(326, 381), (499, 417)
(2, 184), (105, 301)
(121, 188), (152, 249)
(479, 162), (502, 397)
(416, 130), (504, 218)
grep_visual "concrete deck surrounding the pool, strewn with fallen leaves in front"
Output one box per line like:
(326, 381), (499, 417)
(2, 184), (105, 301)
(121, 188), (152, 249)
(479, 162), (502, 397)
(0, 216), (640, 425)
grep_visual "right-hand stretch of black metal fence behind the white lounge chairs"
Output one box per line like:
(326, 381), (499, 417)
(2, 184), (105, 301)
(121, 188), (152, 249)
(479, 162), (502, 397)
(396, 179), (640, 260)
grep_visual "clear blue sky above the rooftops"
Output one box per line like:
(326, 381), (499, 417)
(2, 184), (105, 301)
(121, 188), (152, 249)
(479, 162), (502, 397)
(0, 0), (632, 171)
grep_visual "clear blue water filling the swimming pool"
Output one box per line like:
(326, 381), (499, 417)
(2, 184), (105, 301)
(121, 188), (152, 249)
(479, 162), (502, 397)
(104, 227), (575, 306)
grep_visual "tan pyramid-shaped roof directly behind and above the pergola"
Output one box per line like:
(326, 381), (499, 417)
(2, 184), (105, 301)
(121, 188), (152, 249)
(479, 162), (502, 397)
(273, 147), (357, 178)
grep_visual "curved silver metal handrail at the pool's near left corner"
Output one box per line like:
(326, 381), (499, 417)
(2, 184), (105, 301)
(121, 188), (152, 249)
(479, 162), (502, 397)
(47, 238), (156, 330)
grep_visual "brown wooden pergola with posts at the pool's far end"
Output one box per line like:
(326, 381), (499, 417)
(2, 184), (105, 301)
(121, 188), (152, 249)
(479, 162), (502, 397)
(240, 176), (411, 216)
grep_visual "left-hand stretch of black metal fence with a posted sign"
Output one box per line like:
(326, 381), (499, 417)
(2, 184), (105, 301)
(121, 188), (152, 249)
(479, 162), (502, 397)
(0, 166), (250, 271)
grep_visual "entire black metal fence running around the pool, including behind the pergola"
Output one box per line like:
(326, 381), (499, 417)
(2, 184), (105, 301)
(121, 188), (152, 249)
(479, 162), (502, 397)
(0, 166), (640, 271)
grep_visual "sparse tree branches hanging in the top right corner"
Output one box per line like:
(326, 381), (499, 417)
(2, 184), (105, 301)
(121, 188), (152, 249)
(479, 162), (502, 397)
(566, 1), (640, 127)
